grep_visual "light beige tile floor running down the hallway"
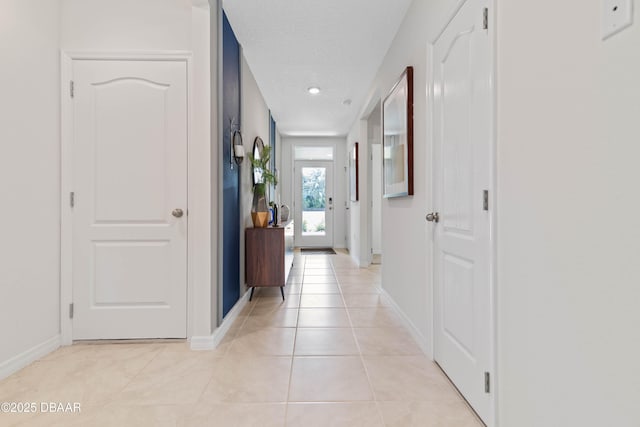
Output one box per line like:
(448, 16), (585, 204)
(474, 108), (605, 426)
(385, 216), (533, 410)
(0, 254), (482, 427)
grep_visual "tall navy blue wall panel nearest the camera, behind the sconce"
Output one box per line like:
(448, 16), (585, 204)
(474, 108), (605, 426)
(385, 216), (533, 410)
(220, 13), (240, 317)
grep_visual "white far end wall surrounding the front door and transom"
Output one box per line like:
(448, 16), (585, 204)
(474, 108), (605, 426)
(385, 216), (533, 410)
(279, 135), (349, 248)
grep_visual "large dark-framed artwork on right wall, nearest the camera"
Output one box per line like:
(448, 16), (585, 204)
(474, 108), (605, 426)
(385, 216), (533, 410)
(382, 67), (413, 198)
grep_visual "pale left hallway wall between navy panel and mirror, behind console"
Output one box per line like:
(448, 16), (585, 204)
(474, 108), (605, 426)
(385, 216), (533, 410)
(239, 55), (273, 294)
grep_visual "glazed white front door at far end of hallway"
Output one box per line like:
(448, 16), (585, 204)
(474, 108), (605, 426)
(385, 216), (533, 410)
(294, 161), (334, 248)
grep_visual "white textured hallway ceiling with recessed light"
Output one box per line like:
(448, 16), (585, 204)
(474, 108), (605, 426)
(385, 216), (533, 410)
(223, 0), (411, 136)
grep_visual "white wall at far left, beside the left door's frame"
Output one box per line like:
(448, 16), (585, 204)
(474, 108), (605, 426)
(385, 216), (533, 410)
(0, 0), (60, 378)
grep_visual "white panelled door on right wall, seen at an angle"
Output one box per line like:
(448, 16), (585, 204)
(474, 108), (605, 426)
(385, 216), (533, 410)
(433, 0), (492, 423)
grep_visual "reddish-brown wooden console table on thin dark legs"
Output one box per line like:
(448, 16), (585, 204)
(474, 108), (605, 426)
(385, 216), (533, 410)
(245, 221), (294, 301)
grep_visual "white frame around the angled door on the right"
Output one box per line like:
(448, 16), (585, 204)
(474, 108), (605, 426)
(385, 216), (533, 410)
(425, 0), (499, 427)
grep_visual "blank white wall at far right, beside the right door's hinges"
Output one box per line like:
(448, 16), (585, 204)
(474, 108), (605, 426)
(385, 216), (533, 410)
(497, 0), (640, 427)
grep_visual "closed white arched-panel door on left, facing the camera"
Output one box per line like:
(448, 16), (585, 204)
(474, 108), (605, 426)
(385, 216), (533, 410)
(73, 60), (187, 340)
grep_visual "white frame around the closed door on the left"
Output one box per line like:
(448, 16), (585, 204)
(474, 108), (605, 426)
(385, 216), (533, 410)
(60, 50), (199, 345)
